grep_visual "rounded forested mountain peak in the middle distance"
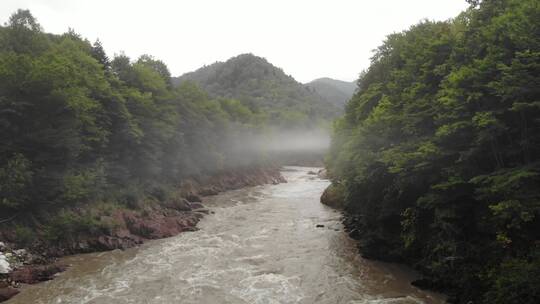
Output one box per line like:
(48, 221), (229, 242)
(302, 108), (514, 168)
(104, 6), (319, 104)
(173, 54), (342, 124)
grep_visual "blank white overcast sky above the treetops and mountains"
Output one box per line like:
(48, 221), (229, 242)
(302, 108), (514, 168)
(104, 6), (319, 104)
(0, 0), (467, 82)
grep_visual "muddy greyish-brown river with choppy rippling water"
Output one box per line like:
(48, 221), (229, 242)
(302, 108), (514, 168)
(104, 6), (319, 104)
(7, 167), (444, 304)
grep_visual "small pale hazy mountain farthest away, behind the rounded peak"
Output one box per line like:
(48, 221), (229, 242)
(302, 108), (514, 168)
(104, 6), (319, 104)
(304, 78), (356, 108)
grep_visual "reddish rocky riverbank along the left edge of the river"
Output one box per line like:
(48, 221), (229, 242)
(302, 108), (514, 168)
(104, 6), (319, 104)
(0, 167), (286, 301)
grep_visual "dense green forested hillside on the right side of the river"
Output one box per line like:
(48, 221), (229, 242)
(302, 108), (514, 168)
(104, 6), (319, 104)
(327, 0), (540, 304)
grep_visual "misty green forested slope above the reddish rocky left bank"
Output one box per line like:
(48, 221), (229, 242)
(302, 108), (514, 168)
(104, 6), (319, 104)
(0, 10), (286, 242)
